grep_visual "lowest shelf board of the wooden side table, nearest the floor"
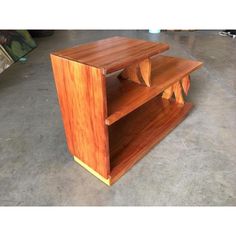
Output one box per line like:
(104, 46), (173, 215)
(109, 96), (192, 183)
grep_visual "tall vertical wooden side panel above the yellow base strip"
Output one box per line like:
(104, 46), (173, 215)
(51, 54), (110, 178)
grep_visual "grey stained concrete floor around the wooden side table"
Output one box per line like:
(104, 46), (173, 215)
(0, 31), (236, 206)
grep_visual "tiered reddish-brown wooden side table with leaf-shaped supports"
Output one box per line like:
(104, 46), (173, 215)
(51, 37), (202, 185)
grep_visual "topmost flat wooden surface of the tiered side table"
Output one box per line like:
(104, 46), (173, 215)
(52, 36), (169, 74)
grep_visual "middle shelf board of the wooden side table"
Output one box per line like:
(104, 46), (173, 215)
(105, 56), (202, 125)
